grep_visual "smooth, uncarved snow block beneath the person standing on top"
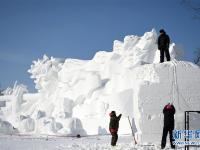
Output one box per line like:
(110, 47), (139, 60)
(138, 61), (200, 142)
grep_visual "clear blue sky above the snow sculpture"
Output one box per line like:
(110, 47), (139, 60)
(0, 0), (200, 91)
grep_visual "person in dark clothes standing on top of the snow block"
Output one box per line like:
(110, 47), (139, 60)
(158, 29), (171, 63)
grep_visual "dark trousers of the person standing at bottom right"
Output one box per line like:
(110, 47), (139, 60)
(161, 127), (175, 148)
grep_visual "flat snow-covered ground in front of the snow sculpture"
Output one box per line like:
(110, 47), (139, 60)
(0, 135), (186, 150)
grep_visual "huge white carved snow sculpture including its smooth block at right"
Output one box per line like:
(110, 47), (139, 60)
(0, 29), (200, 146)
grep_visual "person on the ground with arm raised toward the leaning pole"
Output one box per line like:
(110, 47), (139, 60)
(109, 111), (122, 146)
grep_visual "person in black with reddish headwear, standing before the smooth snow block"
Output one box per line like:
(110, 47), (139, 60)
(161, 103), (176, 149)
